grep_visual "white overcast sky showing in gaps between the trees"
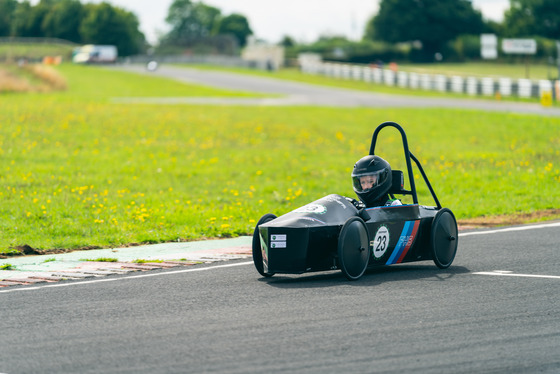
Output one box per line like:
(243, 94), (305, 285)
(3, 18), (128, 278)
(84, 0), (509, 43)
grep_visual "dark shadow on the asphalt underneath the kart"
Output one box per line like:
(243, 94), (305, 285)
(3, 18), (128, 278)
(259, 264), (470, 288)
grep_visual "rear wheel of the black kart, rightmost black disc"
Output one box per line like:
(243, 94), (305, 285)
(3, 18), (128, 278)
(430, 208), (459, 269)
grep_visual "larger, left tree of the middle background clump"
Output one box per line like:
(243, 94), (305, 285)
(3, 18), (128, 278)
(164, 0), (221, 45)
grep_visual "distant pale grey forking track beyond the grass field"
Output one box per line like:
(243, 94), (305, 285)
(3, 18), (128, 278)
(112, 65), (560, 117)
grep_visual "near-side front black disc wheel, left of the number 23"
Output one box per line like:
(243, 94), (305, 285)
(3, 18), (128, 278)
(337, 217), (370, 280)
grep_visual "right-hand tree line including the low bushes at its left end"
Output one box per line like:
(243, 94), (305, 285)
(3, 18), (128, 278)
(298, 0), (560, 62)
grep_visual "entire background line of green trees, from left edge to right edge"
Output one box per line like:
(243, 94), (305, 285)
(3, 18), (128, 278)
(0, 0), (560, 62)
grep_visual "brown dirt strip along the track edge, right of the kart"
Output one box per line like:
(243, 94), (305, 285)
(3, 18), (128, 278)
(457, 209), (560, 230)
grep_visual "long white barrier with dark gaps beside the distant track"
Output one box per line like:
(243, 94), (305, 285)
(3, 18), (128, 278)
(300, 62), (560, 100)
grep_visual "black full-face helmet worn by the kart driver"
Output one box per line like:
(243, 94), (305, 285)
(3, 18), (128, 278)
(352, 155), (393, 207)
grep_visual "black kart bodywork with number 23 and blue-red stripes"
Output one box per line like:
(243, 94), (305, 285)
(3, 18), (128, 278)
(259, 194), (437, 274)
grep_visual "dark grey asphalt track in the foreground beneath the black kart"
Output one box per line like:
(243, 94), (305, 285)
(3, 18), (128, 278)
(0, 223), (560, 374)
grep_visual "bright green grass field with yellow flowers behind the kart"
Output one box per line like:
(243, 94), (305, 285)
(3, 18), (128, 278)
(0, 65), (560, 258)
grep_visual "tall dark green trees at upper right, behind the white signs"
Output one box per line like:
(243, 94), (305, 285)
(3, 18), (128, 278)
(365, 0), (560, 60)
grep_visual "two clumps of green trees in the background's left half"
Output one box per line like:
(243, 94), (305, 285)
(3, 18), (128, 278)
(0, 0), (252, 56)
